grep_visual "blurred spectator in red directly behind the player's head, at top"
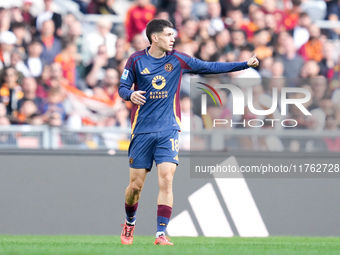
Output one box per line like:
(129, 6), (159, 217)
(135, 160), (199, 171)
(125, 0), (156, 42)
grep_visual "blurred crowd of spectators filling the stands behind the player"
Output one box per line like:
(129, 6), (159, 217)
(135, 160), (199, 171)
(0, 0), (340, 137)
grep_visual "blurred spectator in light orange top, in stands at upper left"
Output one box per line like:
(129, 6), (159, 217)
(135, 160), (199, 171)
(54, 39), (78, 87)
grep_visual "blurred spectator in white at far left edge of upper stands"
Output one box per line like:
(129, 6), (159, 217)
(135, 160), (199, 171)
(0, 31), (17, 69)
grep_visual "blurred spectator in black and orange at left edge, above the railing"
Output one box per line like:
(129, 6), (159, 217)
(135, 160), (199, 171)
(0, 67), (24, 115)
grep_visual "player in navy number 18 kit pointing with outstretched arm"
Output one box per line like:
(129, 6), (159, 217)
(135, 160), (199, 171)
(119, 19), (259, 245)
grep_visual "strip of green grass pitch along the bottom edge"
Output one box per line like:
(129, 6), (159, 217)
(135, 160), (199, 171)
(0, 236), (340, 255)
